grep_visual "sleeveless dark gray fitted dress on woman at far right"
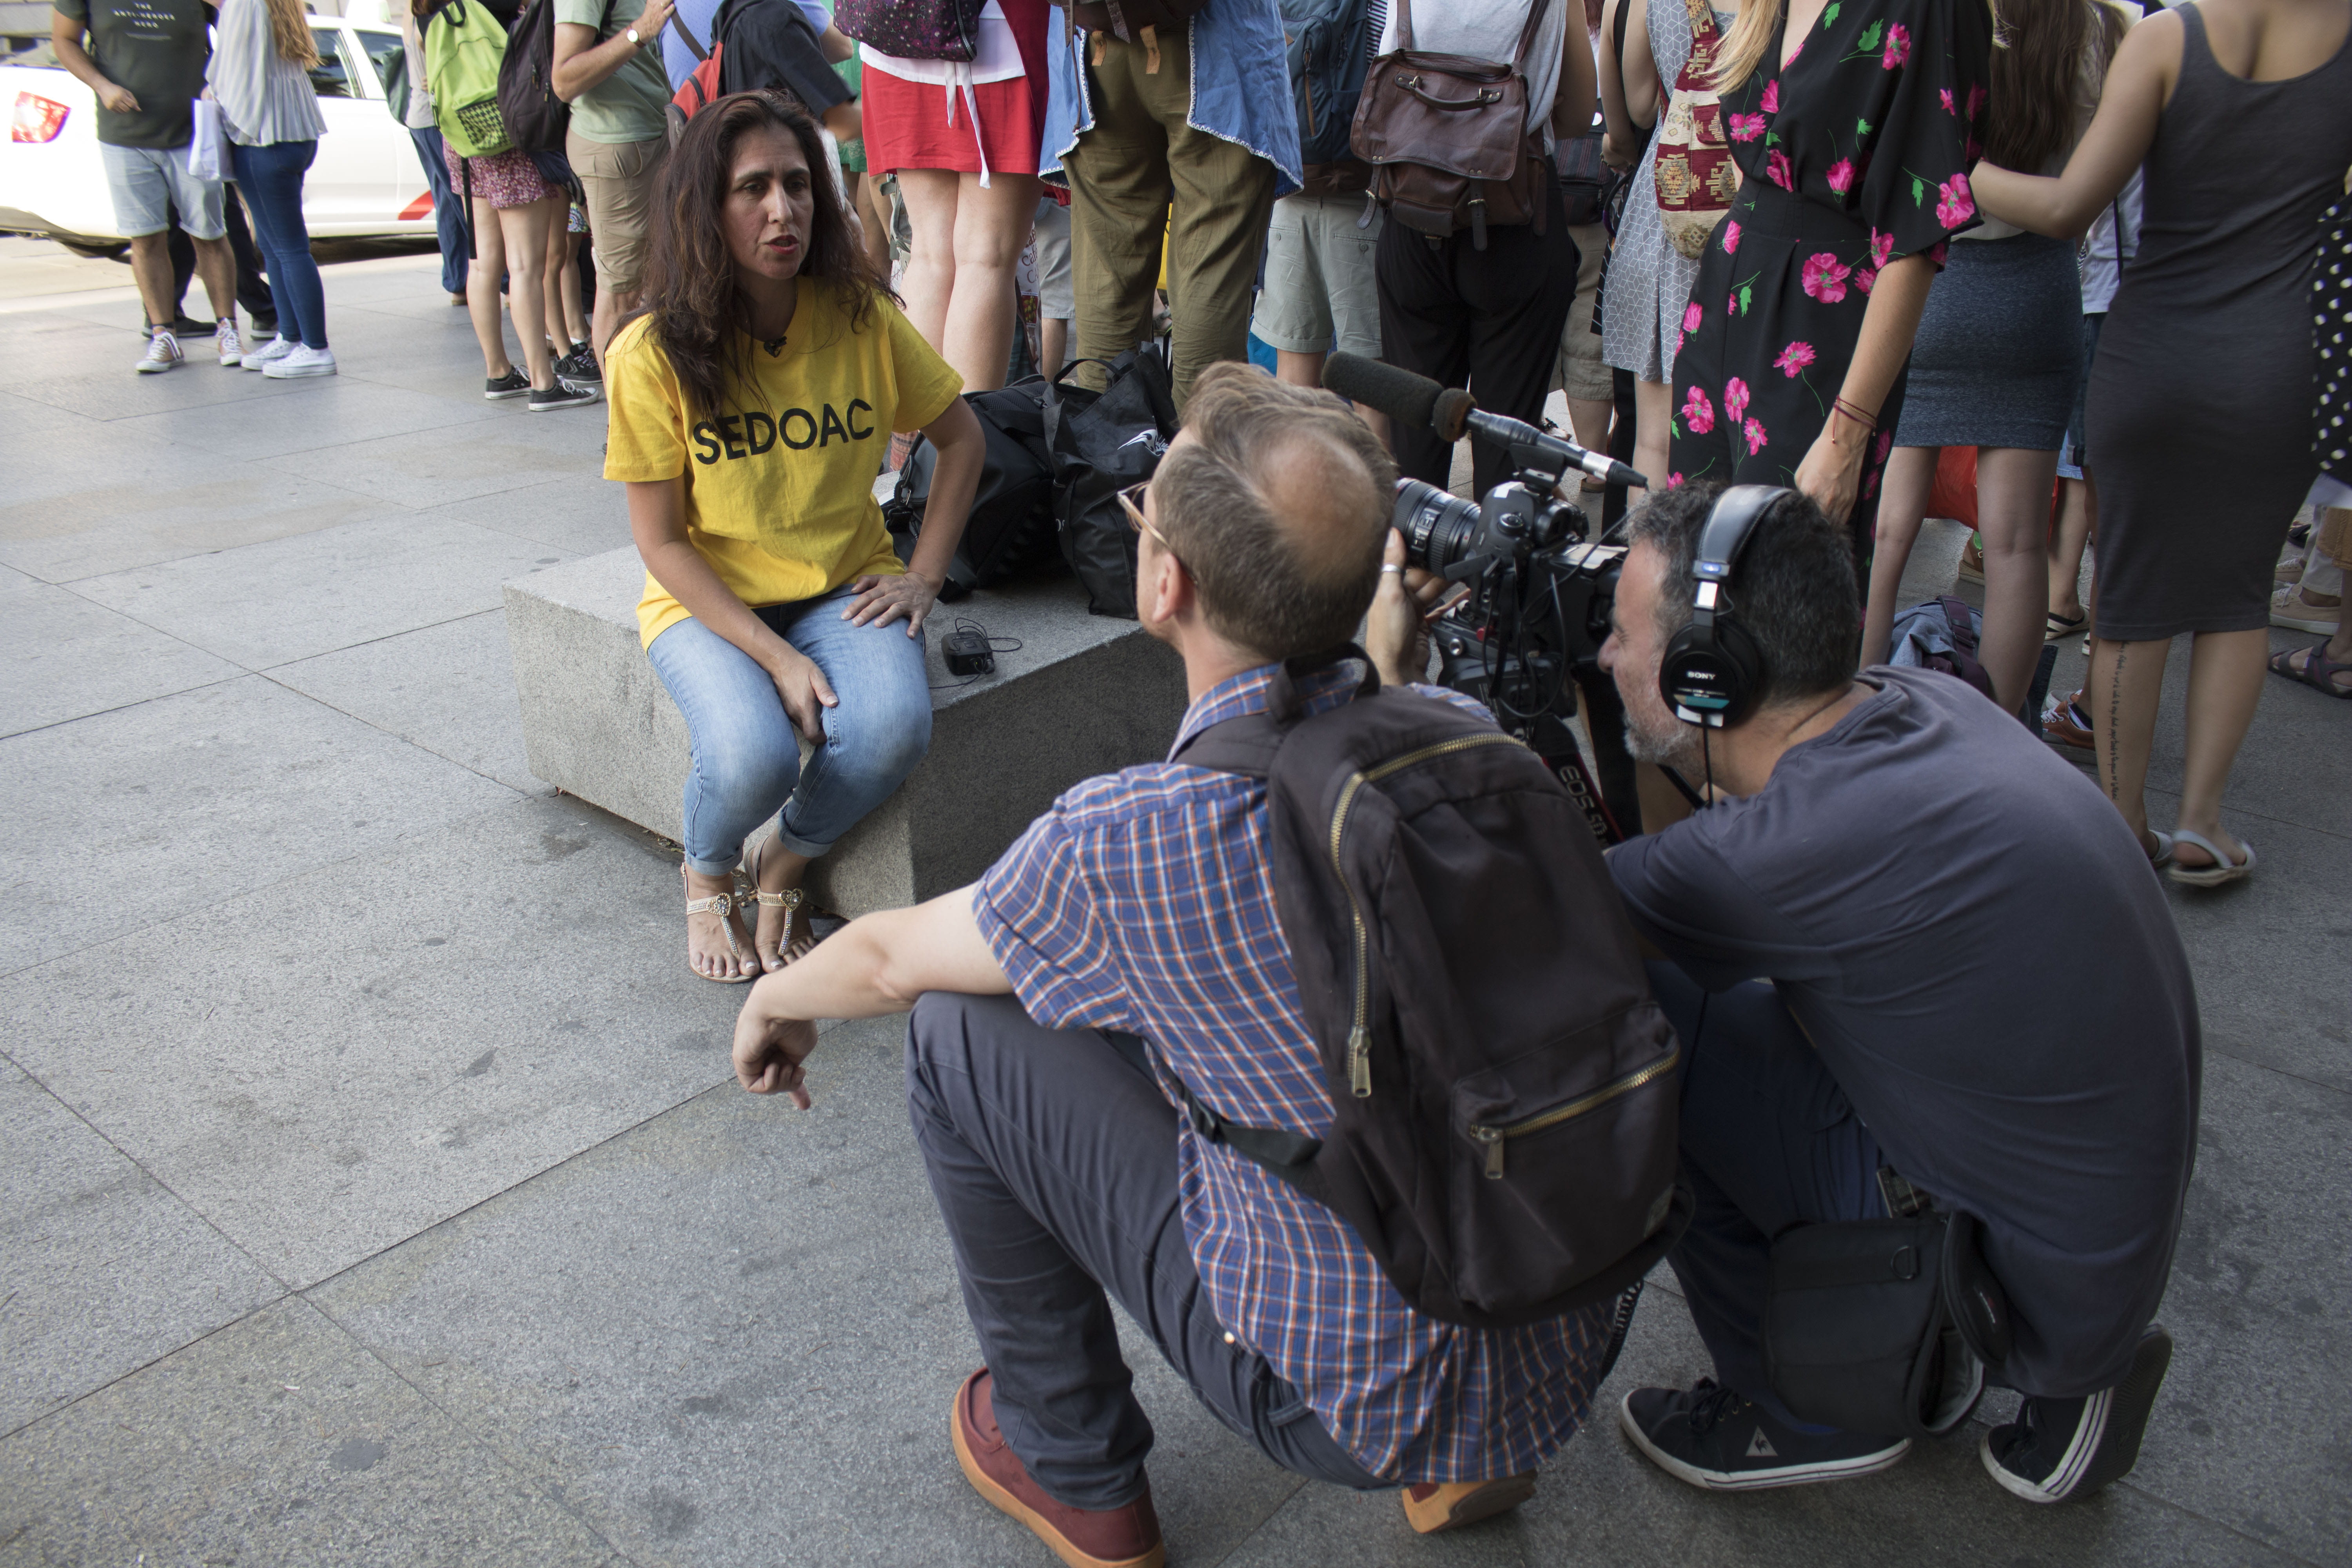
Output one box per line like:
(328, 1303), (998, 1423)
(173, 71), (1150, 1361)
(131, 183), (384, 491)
(2086, 2), (2352, 642)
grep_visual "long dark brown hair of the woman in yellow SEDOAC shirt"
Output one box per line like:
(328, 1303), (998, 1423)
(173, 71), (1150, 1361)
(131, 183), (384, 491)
(644, 89), (896, 416)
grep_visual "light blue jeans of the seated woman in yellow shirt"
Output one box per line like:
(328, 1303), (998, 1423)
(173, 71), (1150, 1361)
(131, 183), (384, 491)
(644, 588), (931, 877)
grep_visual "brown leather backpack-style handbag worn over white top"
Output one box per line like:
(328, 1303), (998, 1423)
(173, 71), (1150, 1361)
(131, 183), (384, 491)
(1350, 0), (1550, 249)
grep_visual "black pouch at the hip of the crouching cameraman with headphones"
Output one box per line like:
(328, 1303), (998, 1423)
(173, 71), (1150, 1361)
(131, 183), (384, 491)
(1764, 1210), (2009, 1436)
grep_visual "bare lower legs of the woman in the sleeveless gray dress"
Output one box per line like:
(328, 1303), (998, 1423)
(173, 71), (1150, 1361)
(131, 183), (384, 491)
(2082, 628), (2270, 870)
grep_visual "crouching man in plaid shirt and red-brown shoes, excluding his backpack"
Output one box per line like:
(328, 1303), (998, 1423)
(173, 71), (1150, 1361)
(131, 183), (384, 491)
(734, 365), (1609, 1566)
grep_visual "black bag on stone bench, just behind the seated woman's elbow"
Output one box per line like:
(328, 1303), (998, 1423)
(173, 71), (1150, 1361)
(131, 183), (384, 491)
(882, 376), (1058, 599)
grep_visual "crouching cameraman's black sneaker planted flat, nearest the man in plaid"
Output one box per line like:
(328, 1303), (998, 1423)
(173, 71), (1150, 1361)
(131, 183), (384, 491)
(1618, 1377), (1910, 1493)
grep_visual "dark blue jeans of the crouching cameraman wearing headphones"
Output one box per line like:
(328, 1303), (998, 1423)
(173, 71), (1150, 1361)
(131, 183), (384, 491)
(1649, 962), (1886, 1432)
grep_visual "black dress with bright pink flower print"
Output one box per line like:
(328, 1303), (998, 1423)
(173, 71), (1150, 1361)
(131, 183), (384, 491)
(1668, 0), (1992, 559)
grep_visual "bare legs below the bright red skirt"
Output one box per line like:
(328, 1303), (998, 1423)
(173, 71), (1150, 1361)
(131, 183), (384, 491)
(898, 169), (1040, 392)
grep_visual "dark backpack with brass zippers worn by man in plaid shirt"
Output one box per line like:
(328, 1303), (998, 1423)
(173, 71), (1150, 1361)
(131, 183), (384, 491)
(1176, 649), (1691, 1328)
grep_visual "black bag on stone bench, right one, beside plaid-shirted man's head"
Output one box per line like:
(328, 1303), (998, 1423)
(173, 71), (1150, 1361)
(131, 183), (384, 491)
(1044, 341), (1176, 621)
